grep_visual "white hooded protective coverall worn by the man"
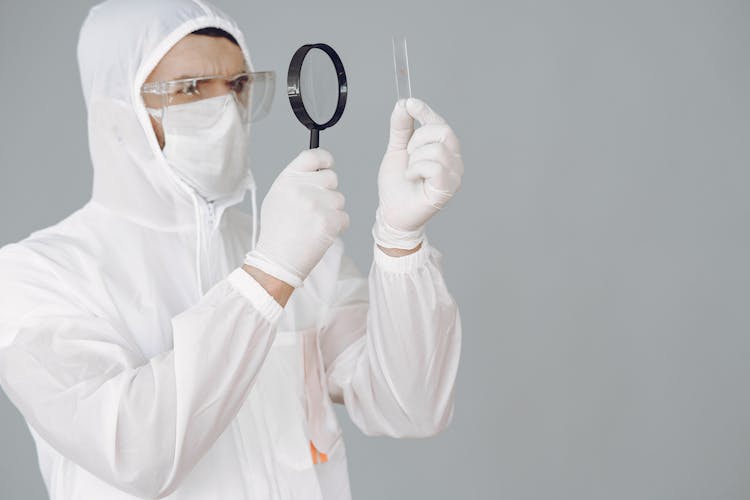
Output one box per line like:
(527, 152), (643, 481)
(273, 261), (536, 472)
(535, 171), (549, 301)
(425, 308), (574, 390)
(0, 0), (461, 500)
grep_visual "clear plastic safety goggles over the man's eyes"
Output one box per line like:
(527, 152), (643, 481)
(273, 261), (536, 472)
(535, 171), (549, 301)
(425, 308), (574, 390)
(141, 71), (276, 123)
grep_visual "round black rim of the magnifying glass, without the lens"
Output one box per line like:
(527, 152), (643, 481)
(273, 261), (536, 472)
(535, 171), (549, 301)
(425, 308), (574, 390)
(287, 43), (348, 130)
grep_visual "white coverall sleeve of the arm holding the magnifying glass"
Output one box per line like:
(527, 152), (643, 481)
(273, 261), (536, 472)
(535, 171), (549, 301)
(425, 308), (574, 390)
(0, 244), (281, 498)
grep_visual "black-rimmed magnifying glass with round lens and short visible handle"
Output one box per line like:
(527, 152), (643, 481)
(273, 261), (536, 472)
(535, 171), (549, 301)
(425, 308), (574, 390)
(287, 43), (348, 149)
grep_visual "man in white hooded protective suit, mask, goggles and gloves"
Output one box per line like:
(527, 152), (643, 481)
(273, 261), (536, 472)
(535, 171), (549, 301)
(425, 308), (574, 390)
(0, 0), (463, 500)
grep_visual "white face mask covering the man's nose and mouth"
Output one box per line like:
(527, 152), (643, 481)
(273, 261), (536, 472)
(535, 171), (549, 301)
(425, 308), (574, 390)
(152, 93), (252, 201)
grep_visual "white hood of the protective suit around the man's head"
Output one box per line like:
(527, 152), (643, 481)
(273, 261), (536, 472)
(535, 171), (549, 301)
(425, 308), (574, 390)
(78, 0), (257, 232)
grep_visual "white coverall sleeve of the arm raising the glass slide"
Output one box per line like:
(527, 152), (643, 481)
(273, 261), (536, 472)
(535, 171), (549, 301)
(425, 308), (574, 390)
(321, 240), (461, 437)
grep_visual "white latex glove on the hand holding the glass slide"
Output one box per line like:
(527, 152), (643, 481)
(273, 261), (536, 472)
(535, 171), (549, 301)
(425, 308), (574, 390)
(372, 98), (464, 250)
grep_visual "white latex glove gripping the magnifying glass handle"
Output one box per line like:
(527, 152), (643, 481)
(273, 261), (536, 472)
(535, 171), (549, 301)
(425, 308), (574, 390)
(244, 148), (349, 288)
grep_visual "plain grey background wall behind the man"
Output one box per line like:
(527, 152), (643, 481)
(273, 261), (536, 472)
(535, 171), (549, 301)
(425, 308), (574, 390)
(0, 0), (750, 500)
